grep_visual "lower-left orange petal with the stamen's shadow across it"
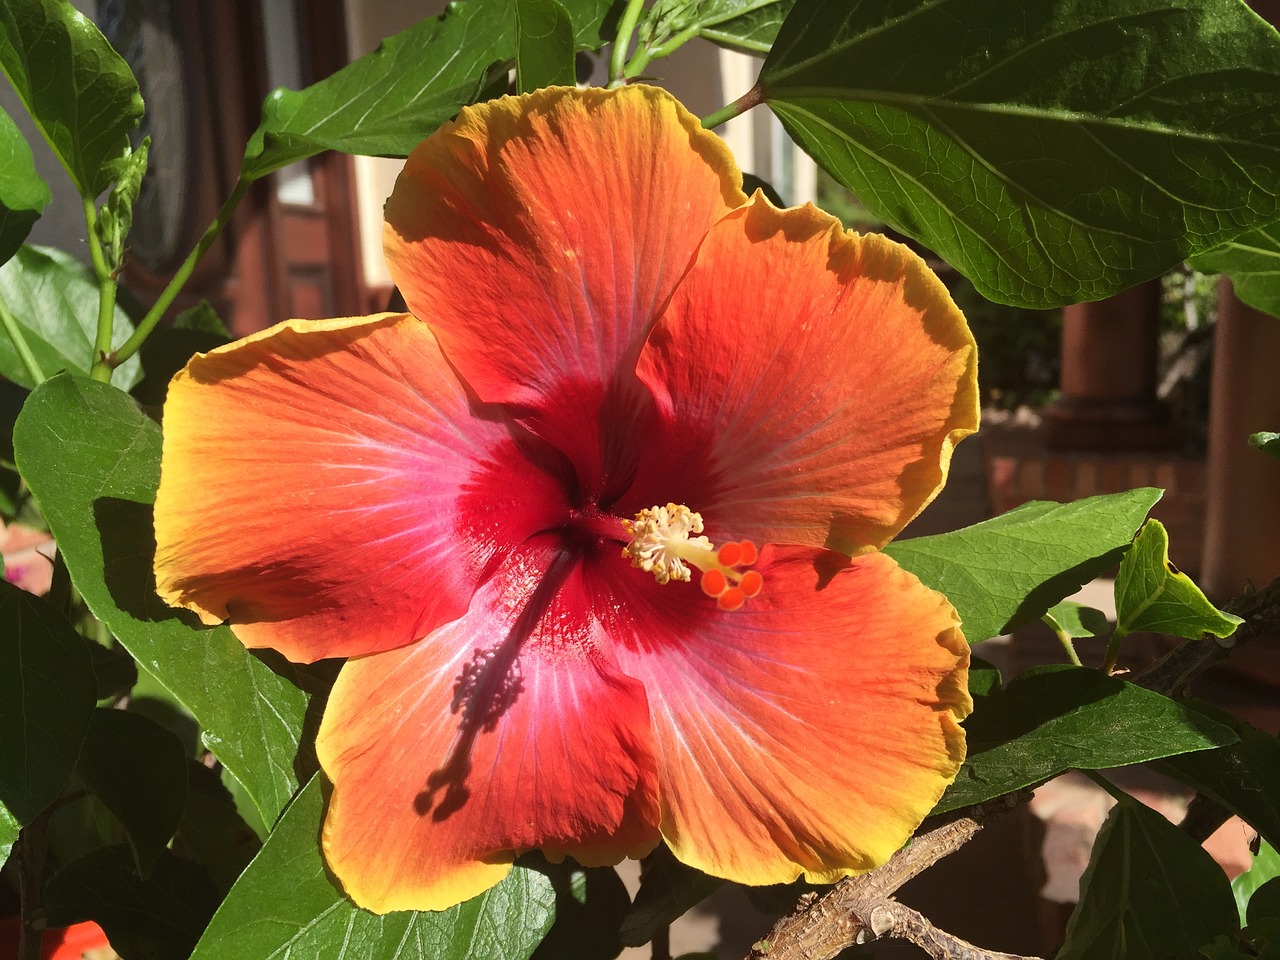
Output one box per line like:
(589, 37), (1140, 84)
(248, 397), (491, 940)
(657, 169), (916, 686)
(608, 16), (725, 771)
(316, 549), (658, 913)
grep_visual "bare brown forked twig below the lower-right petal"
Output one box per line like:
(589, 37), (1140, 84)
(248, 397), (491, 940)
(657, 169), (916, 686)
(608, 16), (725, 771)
(749, 794), (1044, 960)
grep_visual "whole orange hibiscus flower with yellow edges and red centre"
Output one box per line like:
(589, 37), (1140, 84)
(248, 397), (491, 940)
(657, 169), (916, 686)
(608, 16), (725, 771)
(156, 87), (977, 911)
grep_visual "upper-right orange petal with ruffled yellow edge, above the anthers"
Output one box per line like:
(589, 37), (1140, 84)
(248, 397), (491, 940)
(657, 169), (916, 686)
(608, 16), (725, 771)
(629, 195), (978, 553)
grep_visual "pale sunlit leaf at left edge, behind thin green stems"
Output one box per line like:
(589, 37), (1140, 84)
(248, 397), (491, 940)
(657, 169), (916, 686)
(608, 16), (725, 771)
(0, 244), (142, 390)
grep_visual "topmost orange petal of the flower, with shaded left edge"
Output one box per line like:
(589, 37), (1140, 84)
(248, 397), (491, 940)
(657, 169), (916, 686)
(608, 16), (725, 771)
(384, 86), (746, 496)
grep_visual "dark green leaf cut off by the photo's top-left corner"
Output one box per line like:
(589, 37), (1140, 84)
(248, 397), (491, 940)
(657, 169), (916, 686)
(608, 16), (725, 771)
(0, 0), (142, 200)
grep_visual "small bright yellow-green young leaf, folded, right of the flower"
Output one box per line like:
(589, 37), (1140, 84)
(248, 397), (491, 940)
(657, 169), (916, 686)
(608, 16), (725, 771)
(1116, 520), (1244, 640)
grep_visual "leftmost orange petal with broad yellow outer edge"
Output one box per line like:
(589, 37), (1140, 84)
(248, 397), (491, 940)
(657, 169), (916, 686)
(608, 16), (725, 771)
(155, 315), (563, 660)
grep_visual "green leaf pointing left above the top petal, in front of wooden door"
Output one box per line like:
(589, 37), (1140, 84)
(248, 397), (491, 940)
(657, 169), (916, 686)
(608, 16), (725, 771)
(241, 0), (611, 180)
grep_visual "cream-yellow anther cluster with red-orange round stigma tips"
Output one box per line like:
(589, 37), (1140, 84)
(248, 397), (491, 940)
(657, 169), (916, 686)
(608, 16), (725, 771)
(622, 503), (764, 611)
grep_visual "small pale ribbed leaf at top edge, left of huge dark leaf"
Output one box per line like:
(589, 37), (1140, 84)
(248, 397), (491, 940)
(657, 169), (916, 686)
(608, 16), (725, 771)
(639, 0), (795, 57)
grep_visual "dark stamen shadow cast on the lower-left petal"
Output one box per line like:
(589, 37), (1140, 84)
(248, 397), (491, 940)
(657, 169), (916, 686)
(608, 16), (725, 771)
(413, 549), (576, 820)
